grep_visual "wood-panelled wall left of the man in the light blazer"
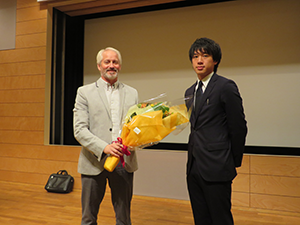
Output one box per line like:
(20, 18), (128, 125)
(0, 0), (52, 193)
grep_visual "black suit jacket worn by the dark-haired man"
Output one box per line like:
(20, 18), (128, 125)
(185, 73), (247, 181)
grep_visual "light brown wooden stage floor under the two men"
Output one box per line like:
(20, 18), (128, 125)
(0, 181), (300, 225)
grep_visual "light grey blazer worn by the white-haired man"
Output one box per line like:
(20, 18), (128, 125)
(73, 78), (138, 175)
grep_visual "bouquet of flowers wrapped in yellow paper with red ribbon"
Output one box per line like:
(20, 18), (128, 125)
(104, 94), (189, 172)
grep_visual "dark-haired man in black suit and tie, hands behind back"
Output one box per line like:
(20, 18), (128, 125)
(185, 38), (247, 225)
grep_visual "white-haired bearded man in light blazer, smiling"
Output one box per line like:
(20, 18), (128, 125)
(73, 47), (138, 225)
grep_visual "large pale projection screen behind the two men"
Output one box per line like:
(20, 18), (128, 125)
(84, 0), (300, 147)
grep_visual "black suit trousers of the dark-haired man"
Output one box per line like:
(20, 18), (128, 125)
(187, 160), (234, 225)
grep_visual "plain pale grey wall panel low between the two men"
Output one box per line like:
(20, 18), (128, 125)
(133, 149), (189, 200)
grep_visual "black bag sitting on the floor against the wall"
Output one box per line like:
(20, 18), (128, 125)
(45, 170), (74, 193)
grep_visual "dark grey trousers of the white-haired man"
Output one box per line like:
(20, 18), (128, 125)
(81, 164), (133, 225)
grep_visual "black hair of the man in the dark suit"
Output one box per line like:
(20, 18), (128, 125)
(189, 38), (222, 72)
